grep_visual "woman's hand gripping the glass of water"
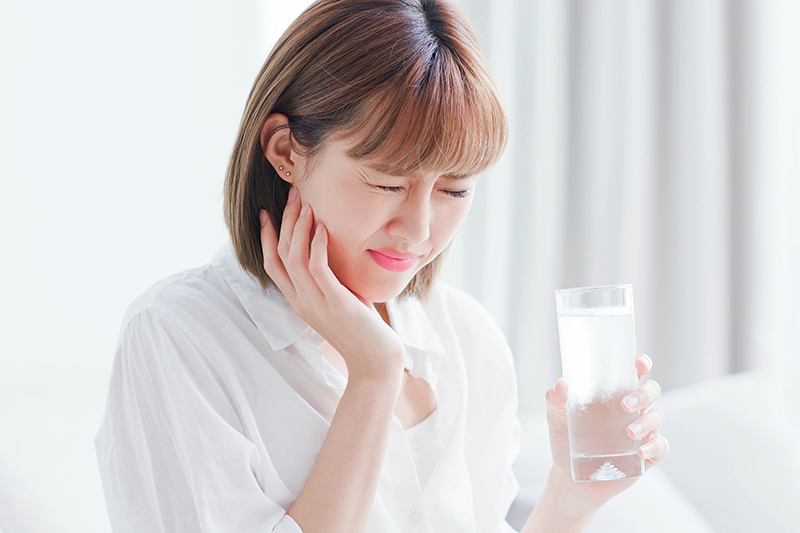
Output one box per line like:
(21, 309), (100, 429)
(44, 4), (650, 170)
(545, 355), (668, 513)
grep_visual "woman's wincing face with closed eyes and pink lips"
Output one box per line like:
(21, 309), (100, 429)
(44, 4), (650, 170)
(293, 140), (477, 302)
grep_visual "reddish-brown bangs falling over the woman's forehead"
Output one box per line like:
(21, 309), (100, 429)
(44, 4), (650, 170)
(346, 46), (508, 175)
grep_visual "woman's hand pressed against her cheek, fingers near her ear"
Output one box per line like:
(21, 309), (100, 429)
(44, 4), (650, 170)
(260, 188), (405, 379)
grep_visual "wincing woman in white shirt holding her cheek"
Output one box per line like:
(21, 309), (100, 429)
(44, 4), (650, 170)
(97, 0), (667, 533)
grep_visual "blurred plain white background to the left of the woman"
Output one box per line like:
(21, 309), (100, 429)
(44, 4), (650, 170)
(0, 0), (302, 532)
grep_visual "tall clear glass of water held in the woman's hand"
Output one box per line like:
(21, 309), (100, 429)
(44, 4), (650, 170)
(556, 285), (644, 481)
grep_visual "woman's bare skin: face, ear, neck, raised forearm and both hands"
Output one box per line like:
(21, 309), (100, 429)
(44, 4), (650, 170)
(261, 114), (668, 533)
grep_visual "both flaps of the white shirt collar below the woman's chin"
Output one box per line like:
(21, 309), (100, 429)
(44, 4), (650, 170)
(211, 242), (445, 355)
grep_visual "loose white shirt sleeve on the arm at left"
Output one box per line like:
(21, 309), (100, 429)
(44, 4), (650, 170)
(96, 309), (302, 533)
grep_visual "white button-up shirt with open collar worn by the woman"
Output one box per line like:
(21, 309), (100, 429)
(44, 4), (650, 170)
(96, 245), (520, 533)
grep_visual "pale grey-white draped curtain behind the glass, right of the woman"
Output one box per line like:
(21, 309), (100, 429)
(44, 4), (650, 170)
(453, 0), (800, 428)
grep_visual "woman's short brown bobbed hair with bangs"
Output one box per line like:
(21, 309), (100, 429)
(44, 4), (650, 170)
(225, 0), (508, 297)
